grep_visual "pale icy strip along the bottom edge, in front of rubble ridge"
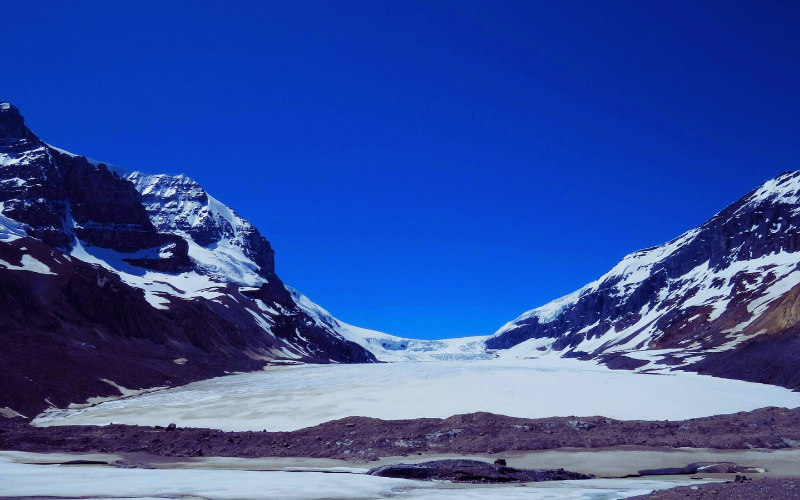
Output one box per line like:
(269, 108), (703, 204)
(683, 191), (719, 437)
(0, 452), (712, 500)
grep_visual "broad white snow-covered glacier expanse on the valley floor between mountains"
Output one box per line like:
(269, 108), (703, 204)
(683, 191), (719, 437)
(34, 357), (800, 431)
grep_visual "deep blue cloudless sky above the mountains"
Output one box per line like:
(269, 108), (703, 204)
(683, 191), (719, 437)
(0, 0), (800, 338)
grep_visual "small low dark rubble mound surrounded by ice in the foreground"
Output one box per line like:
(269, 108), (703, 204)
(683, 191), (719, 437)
(367, 459), (594, 484)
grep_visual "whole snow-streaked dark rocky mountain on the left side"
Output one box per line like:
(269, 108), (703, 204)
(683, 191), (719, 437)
(0, 101), (376, 418)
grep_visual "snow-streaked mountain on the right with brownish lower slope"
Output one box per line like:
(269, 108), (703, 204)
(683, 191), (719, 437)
(486, 171), (800, 388)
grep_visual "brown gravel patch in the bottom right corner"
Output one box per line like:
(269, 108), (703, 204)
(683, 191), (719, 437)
(628, 477), (800, 500)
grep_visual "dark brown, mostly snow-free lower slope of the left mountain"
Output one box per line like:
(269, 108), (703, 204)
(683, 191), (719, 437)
(0, 238), (288, 418)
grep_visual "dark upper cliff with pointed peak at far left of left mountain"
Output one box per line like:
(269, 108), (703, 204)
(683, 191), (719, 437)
(0, 101), (191, 272)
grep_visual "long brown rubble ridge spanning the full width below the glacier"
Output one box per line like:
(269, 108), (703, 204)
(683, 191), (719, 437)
(0, 408), (800, 463)
